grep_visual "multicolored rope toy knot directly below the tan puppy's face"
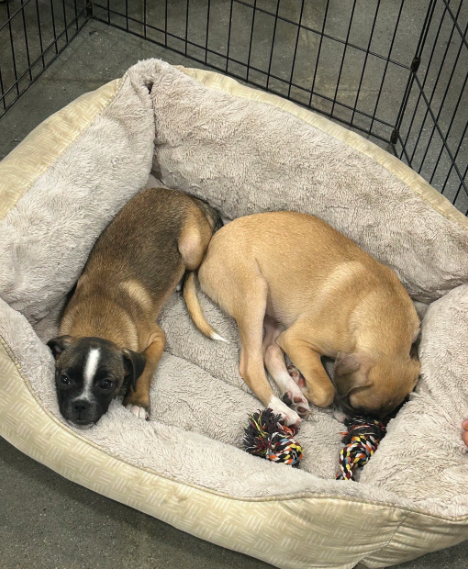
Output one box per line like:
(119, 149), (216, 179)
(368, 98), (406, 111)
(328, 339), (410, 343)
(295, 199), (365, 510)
(336, 417), (387, 480)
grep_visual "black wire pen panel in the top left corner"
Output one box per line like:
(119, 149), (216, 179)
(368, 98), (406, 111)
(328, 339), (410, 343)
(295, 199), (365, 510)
(0, 0), (90, 117)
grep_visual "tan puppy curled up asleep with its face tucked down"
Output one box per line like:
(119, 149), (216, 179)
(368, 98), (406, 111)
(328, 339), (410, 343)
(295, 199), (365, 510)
(184, 212), (420, 424)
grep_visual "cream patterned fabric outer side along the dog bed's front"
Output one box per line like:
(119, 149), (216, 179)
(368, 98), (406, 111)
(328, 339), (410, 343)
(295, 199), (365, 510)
(0, 337), (467, 569)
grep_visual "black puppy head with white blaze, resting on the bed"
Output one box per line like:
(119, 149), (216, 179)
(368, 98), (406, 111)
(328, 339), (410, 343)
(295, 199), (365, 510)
(47, 336), (146, 427)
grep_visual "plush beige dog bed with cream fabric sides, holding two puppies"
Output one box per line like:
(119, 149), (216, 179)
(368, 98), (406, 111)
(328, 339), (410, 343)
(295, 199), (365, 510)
(0, 60), (468, 569)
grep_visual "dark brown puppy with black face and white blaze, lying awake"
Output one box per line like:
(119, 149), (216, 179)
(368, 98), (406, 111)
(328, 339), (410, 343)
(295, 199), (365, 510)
(48, 188), (222, 426)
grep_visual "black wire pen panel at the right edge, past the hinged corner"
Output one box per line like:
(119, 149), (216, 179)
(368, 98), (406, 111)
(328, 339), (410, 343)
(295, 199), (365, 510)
(396, 0), (468, 215)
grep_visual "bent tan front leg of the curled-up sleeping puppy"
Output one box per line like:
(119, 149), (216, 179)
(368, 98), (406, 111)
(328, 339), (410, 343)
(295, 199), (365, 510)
(276, 326), (335, 407)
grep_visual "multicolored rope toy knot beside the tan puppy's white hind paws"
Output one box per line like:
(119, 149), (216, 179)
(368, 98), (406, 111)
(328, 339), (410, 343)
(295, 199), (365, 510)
(243, 409), (302, 467)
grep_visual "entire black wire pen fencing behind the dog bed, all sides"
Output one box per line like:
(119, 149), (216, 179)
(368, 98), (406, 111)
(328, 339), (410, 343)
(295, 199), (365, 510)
(0, 0), (468, 212)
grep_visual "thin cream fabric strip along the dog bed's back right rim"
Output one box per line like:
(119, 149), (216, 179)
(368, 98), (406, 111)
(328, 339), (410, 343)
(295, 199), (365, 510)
(177, 65), (468, 231)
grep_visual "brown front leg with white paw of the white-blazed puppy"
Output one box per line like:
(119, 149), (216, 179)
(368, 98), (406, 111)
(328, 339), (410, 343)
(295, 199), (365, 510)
(124, 324), (166, 419)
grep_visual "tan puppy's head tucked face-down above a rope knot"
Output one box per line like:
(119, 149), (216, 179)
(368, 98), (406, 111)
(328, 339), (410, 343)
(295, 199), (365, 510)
(334, 353), (421, 418)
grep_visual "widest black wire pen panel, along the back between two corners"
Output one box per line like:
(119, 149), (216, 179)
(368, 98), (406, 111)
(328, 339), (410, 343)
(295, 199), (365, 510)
(94, 0), (429, 142)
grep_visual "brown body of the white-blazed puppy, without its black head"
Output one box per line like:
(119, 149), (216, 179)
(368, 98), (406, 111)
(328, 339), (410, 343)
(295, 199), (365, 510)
(60, 188), (219, 410)
